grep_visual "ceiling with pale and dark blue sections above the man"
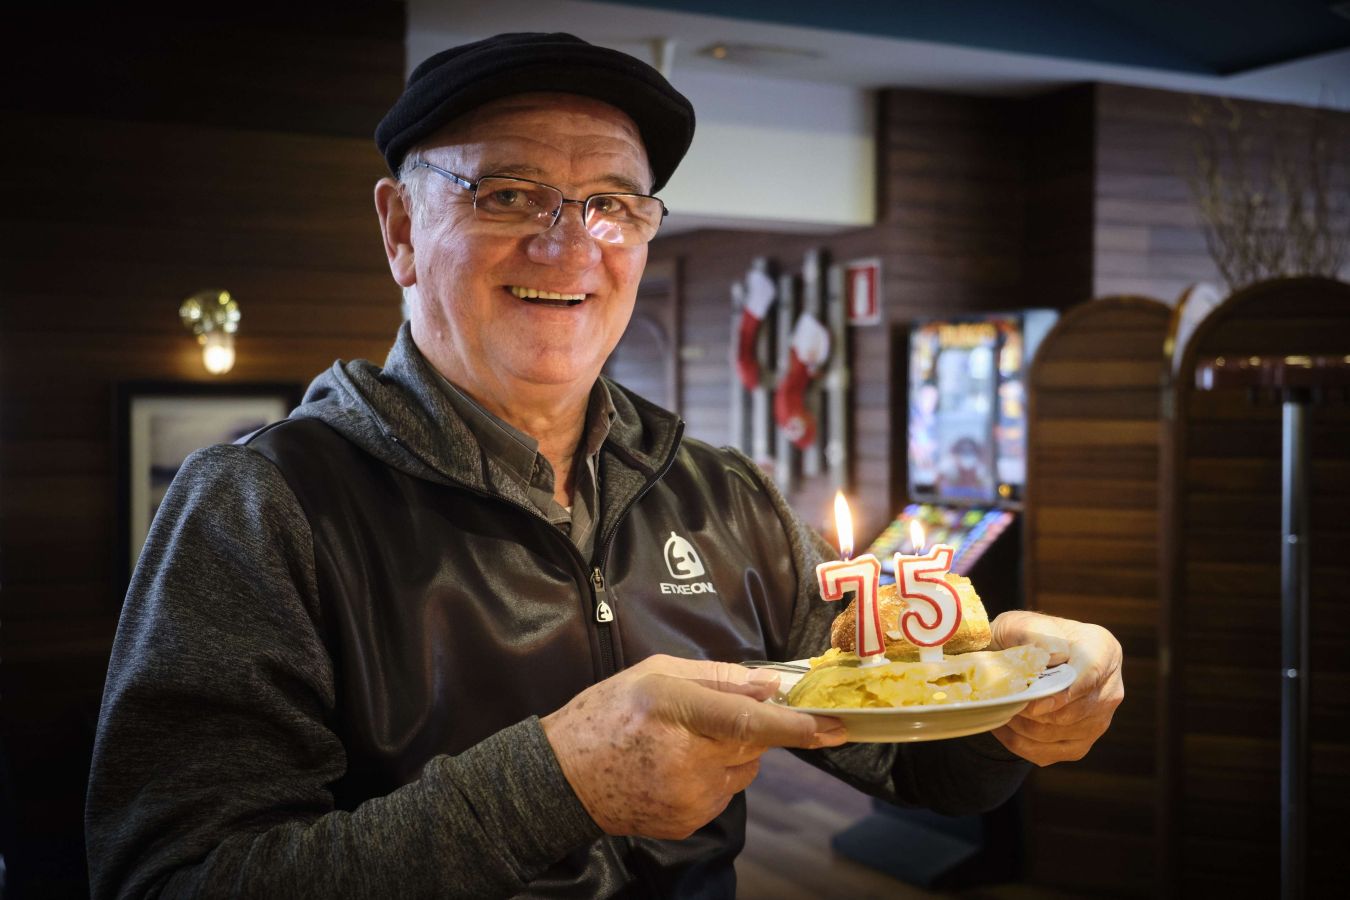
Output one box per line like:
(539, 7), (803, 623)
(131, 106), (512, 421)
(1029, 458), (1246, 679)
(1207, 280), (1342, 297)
(408, 0), (1350, 109)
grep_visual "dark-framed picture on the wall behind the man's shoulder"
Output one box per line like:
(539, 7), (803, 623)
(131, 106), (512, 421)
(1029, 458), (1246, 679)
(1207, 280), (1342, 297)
(115, 382), (302, 595)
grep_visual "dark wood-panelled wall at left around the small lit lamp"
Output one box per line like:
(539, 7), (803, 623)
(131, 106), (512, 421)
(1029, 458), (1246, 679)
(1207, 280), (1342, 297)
(0, 10), (404, 897)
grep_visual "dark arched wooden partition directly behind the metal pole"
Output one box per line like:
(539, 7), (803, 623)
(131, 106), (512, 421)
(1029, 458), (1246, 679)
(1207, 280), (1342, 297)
(1160, 278), (1350, 897)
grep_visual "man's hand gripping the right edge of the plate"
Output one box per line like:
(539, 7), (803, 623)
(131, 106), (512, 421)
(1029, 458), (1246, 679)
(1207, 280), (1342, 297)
(992, 610), (1125, 765)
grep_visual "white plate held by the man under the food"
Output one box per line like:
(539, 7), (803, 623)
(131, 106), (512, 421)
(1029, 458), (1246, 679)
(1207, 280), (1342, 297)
(770, 660), (1077, 743)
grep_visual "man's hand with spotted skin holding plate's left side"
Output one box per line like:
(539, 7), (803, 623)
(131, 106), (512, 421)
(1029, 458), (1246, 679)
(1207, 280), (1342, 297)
(543, 656), (846, 838)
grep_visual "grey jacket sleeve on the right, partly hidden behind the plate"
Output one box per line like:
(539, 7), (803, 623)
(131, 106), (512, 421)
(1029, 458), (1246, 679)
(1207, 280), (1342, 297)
(730, 449), (1031, 815)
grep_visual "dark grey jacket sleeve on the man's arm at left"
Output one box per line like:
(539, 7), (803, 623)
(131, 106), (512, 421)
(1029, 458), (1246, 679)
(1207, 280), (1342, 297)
(85, 445), (599, 899)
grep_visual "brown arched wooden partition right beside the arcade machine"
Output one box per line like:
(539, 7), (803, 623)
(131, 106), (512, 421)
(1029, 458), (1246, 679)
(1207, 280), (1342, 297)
(1023, 297), (1172, 896)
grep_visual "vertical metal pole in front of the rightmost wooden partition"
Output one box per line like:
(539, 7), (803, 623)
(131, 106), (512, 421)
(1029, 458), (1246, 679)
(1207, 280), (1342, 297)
(1280, 390), (1308, 900)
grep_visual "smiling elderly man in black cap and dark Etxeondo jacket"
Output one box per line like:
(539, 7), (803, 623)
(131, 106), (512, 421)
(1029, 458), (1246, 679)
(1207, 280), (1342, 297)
(88, 34), (1122, 897)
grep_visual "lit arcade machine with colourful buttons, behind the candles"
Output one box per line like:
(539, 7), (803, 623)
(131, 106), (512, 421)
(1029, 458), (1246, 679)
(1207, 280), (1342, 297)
(833, 309), (1058, 889)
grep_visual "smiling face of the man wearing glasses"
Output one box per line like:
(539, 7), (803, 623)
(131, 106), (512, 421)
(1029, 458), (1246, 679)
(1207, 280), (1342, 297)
(396, 93), (652, 405)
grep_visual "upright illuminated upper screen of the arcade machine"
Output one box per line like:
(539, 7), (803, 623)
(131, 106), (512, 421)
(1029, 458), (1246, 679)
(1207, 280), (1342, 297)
(907, 310), (1056, 506)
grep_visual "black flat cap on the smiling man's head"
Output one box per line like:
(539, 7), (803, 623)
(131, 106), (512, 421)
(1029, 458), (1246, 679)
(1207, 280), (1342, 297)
(375, 32), (694, 193)
